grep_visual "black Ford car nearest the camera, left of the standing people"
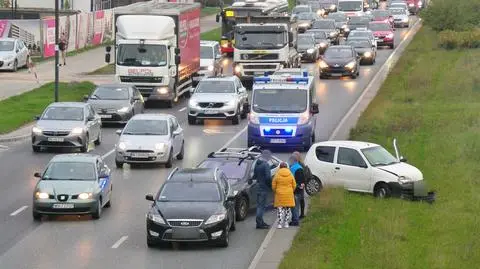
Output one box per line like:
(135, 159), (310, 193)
(145, 168), (235, 247)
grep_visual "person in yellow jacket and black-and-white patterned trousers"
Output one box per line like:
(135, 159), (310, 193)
(272, 162), (297, 229)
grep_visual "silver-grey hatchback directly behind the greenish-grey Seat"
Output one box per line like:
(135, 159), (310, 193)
(32, 102), (102, 152)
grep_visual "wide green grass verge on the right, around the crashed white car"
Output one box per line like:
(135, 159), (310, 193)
(280, 27), (480, 269)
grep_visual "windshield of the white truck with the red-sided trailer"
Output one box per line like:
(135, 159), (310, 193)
(117, 44), (168, 67)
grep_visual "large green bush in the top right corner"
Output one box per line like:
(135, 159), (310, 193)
(420, 0), (480, 32)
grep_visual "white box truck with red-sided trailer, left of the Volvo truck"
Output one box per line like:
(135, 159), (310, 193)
(105, 1), (200, 107)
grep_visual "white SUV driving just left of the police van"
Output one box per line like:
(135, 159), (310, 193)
(188, 76), (249, 125)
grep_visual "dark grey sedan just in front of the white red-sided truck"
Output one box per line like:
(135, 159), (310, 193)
(84, 84), (145, 124)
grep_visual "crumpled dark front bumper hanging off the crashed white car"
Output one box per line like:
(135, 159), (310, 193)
(388, 180), (436, 203)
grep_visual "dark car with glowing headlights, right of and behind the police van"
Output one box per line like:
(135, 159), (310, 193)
(319, 45), (360, 79)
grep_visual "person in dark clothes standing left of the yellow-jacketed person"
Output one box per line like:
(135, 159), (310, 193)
(249, 150), (272, 229)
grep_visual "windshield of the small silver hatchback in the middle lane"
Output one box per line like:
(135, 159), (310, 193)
(122, 119), (168, 135)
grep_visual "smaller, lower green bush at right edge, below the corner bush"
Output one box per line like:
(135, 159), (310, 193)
(438, 28), (480, 49)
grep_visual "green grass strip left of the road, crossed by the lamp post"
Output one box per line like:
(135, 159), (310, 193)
(0, 81), (95, 134)
